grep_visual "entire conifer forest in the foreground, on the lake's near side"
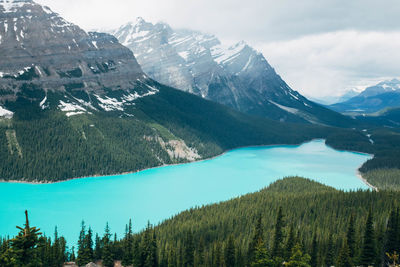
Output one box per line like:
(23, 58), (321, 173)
(0, 178), (400, 267)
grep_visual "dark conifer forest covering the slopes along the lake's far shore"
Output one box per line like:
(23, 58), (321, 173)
(0, 82), (400, 184)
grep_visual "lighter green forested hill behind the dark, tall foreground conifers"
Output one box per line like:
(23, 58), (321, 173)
(151, 178), (400, 266)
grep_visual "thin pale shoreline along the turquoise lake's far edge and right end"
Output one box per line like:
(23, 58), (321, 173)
(0, 138), (377, 186)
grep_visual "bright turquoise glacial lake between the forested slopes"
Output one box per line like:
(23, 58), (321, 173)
(0, 140), (371, 244)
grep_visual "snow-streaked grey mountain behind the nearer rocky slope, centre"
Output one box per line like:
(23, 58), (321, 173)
(111, 18), (354, 126)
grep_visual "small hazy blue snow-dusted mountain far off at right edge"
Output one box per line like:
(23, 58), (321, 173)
(329, 79), (400, 114)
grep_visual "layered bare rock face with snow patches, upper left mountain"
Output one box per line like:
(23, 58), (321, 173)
(0, 0), (156, 115)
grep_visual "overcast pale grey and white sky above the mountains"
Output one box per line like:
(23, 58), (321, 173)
(36, 0), (400, 101)
